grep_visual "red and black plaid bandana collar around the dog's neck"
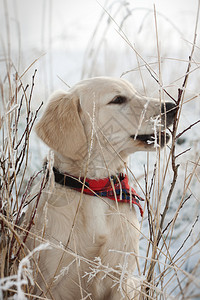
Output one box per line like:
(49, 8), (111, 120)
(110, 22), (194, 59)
(53, 168), (144, 216)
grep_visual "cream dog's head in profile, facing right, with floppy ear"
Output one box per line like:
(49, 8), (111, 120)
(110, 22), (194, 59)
(36, 77), (176, 160)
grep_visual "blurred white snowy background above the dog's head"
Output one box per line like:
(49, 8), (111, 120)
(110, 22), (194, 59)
(0, 0), (200, 97)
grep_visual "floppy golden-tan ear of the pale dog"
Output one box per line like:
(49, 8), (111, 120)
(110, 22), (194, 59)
(35, 91), (87, 160)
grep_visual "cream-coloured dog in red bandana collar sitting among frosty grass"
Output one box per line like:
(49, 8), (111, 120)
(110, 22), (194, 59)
(26, 77), (175, 300)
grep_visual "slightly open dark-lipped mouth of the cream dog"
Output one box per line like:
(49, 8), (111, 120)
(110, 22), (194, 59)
(131, 131), (170, 147)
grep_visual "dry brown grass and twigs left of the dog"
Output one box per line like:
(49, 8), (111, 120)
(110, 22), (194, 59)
(0, 62), (45, 299)
